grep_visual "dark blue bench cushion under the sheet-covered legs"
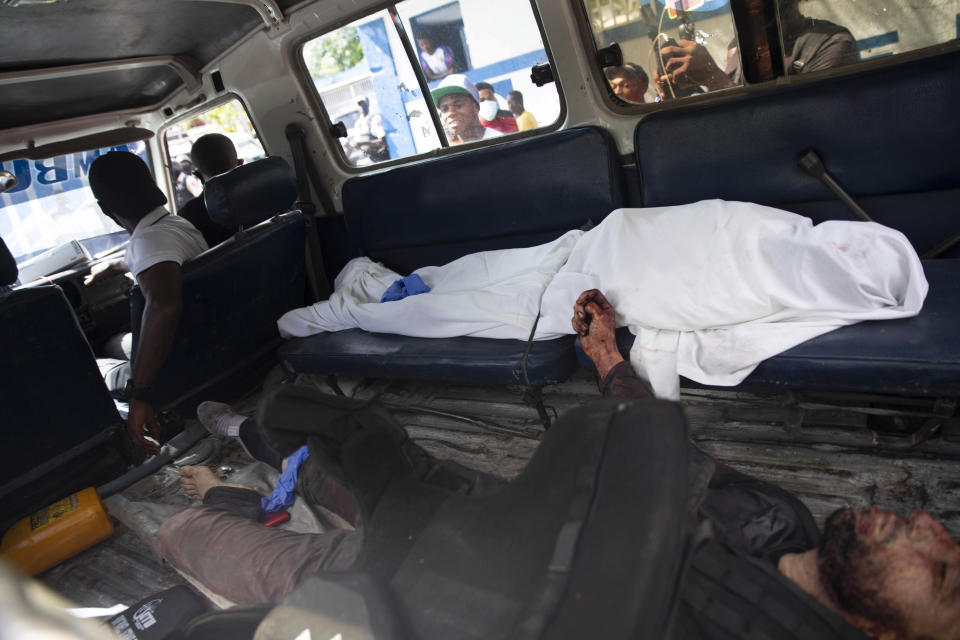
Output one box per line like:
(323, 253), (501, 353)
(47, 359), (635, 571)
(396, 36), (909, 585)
(279, 329), (577, 386)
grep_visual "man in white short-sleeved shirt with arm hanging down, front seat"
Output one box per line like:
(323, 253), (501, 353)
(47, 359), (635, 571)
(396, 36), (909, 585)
(89, 151), (207, 454)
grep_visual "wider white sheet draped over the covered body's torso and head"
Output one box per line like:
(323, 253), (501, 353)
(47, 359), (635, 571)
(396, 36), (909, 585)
(540, 200), (928, 398)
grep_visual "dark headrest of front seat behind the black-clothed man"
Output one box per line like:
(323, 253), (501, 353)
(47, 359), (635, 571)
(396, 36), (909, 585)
(203, 156), (297, 229)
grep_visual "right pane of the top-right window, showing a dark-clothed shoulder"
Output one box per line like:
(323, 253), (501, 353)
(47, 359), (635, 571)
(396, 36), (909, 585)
(778, 0), (960, 74)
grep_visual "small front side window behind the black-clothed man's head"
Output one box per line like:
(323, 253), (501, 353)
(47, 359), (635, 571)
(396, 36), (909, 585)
(163, 98), (267, 211)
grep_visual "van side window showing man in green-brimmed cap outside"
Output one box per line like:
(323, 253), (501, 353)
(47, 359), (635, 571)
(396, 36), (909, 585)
(301, 0), (560, 166)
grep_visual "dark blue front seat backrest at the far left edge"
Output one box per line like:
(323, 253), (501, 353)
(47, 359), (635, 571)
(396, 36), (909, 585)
(0, 235), (122, 516)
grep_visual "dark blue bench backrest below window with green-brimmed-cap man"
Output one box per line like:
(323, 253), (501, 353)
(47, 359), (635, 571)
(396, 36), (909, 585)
(342, 127), (625, 276)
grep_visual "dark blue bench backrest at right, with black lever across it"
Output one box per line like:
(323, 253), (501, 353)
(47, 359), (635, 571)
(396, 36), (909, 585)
(634, 52), (960, 255)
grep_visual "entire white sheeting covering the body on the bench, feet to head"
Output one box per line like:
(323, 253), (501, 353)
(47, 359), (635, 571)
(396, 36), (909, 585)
(278, 200), (927, 398)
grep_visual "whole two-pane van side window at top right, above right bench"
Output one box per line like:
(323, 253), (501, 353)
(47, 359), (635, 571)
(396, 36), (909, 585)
(584, 0), (960, 104)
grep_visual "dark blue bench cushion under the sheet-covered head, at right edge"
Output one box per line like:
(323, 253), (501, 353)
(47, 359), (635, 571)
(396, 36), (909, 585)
(576, 260), (960, 396)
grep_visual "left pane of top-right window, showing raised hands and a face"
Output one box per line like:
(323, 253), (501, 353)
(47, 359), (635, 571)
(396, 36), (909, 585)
(584, 0), (743, 104)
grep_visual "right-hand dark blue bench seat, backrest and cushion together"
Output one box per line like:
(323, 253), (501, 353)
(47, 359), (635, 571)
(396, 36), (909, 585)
(621, 51), (960, 397)
